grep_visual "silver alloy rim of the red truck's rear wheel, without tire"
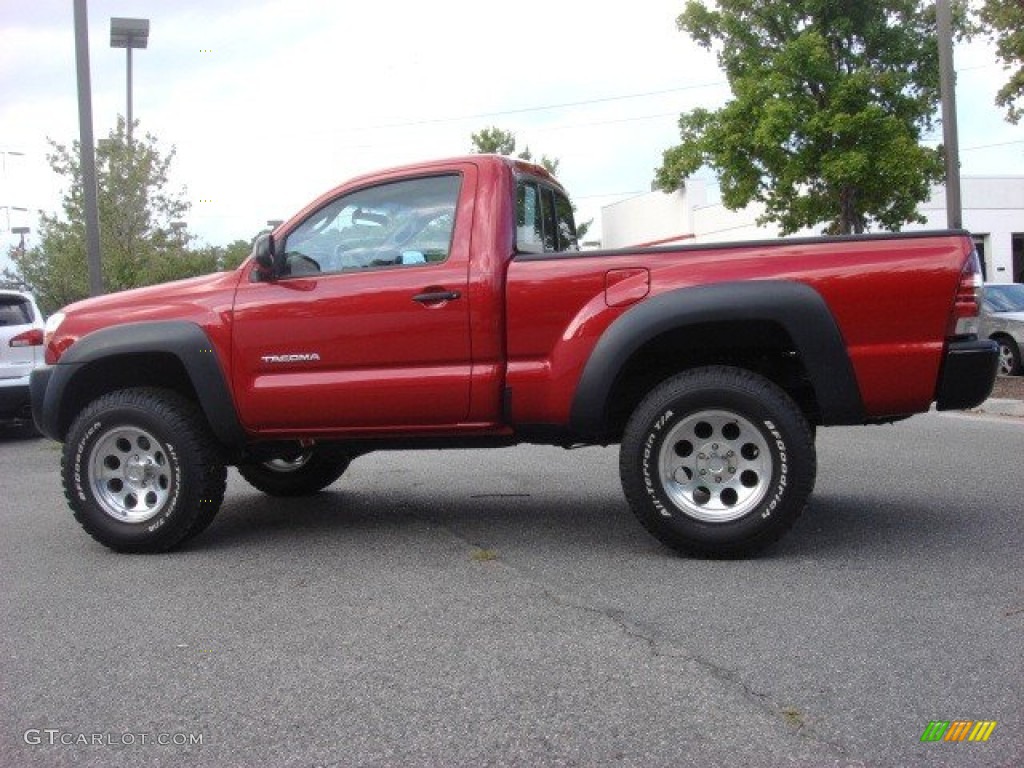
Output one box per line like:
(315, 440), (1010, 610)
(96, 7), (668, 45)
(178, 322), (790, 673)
(658, 411), (773, 522)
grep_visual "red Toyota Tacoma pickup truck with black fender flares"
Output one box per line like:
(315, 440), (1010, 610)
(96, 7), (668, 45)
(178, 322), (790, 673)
(32, 156), (997, 557)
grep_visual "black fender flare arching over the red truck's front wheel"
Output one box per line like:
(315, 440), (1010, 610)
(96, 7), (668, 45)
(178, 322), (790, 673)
(32, 321), (245, 446)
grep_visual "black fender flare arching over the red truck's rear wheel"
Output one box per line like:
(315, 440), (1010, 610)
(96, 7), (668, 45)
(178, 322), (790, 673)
(569, 281), (864, 437)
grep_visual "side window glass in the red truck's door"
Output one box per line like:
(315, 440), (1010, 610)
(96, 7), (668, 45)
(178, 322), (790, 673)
(285, 175), (462, 275)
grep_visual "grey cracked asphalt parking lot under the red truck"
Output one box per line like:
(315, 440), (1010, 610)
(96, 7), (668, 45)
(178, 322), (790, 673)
(0, 415), (1024, 766)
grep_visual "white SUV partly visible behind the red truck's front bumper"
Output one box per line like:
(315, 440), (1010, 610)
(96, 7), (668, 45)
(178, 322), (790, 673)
(0, 289), (43, 429)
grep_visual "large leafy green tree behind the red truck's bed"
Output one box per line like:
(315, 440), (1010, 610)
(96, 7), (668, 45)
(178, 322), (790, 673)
(655, 0), (965, 234)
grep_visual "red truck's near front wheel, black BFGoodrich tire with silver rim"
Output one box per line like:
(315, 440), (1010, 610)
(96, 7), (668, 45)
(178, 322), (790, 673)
(61, 388), (226, 552)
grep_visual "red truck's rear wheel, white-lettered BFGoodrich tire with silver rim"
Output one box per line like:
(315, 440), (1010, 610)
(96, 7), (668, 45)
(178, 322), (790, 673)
(620, 367), (816, 557)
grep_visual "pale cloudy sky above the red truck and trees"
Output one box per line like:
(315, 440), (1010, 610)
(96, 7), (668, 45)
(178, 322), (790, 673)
(0, 0), (1024, 266)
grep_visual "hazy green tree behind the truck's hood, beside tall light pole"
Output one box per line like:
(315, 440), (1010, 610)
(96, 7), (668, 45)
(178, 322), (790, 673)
(4, 119), (218, 313)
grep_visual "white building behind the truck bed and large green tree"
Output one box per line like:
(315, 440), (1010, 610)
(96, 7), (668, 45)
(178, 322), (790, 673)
(601, 176), (1024, 283)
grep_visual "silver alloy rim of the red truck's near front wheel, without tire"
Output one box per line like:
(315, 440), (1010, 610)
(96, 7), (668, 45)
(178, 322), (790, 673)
(88, 427), (175, 523)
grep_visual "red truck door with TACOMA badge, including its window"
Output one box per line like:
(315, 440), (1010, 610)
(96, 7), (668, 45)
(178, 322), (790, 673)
(232, 166), (476, 432)
